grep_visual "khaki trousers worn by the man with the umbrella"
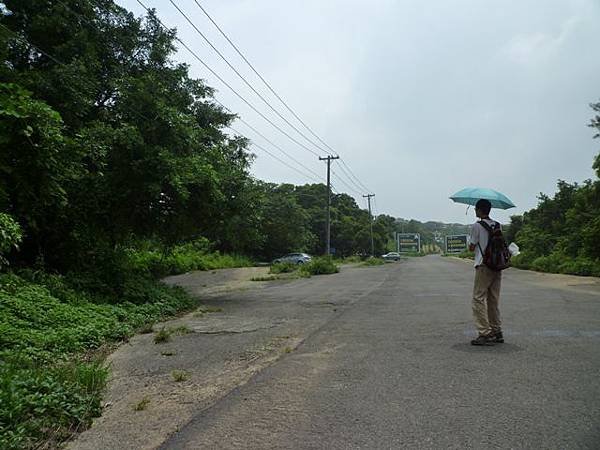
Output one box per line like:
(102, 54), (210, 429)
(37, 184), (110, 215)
(473, 265), (502, 335)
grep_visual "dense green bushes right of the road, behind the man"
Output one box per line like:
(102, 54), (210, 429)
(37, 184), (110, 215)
(510, 103), (600, 276)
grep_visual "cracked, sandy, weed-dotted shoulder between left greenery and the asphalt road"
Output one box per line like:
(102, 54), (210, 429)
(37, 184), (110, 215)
(68, 267), (385, 449)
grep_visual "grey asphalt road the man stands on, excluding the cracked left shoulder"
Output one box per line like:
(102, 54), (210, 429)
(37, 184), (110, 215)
(163, 256), (600, 449)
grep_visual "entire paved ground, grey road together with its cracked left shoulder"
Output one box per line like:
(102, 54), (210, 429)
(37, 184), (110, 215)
(73, 256), (600, 449)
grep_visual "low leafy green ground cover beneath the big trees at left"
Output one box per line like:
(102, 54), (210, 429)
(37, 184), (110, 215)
(0, 272), (197, 449)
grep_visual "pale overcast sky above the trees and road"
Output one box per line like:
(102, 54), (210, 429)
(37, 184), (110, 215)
(118, 0), (600, 223)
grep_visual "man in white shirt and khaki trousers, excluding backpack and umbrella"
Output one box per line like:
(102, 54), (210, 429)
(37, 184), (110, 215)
(469, 199), (504, 345)
